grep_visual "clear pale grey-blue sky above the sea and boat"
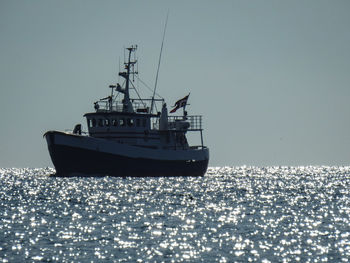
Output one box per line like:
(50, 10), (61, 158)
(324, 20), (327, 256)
(0, 0), (350, 167)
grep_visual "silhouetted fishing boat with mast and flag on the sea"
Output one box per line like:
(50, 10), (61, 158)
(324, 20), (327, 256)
(44, 45), (209, 177)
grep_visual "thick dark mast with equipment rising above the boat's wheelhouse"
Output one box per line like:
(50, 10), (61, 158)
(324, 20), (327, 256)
(117, 45), (137, 112)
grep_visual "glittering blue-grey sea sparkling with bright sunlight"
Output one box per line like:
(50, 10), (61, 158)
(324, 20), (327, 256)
(0, 166), (350, 262)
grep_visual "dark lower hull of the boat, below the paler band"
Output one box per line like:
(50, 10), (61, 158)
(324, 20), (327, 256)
(49, 135), (208, 177)
